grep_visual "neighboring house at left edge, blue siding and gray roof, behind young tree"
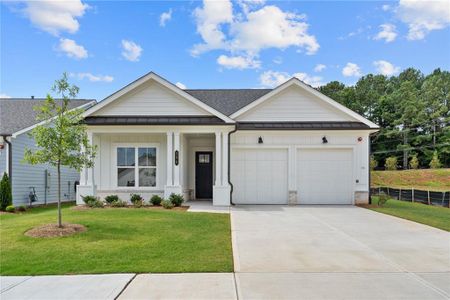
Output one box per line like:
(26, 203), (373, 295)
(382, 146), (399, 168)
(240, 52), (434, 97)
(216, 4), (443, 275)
(0, 98), (95, 205)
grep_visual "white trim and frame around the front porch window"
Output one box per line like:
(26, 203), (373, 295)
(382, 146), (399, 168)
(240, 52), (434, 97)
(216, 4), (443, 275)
(111, 143), (161, 191)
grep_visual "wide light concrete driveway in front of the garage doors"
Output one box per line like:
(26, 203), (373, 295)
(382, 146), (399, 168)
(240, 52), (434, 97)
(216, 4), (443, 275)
(231, 206), (450, 299)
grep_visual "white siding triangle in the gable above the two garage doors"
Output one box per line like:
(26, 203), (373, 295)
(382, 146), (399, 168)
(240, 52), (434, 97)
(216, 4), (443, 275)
(237, 86), (355, 122)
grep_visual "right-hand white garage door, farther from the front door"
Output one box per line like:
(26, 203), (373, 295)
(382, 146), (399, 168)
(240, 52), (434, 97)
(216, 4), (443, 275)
(297, 149), (353, 204)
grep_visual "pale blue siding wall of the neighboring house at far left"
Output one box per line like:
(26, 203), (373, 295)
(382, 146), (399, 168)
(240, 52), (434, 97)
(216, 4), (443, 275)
(10, 133), (80, 206)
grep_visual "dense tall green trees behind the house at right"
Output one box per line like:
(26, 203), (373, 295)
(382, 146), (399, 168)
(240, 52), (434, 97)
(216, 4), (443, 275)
(319, 68), (450, 168)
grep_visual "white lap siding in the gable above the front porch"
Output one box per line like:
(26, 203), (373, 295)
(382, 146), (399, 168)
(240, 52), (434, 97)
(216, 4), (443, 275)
(93, 81), (211, 116)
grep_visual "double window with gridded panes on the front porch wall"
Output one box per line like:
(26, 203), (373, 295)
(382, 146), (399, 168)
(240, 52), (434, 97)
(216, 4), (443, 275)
(117, 147), (157, 187)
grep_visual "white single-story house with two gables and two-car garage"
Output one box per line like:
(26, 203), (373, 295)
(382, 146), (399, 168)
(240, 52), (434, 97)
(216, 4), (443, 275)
(77, 72), (379, 205)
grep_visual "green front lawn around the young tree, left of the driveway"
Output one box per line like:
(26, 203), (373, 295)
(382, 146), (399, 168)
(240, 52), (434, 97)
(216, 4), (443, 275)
(0, 206), (233, 275)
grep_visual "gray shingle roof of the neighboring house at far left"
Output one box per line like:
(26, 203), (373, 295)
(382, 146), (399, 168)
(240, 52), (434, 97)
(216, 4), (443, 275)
(0, 98), (95, 135)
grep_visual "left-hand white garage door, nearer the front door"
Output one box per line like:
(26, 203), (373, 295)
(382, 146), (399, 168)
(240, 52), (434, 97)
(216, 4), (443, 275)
(231, 149), (288, 204)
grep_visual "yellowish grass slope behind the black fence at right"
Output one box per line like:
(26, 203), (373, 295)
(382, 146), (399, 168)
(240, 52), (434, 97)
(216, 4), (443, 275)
(371, 169), (450, 191)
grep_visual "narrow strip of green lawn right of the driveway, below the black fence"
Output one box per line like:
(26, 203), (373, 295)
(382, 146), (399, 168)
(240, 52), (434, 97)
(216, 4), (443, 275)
(370, 197), (450, 231)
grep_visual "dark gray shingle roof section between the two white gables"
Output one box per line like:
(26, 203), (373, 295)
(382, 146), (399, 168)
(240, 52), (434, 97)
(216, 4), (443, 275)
(184, 89), (272, 116)
